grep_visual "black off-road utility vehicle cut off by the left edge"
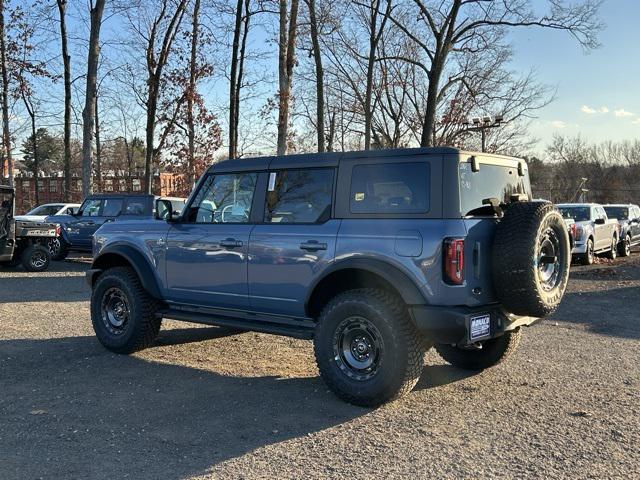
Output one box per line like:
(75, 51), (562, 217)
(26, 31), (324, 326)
(0, 185), (60, 272)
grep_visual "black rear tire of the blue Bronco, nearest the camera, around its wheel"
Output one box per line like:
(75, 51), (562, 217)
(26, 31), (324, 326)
(314, 289), (428, 407)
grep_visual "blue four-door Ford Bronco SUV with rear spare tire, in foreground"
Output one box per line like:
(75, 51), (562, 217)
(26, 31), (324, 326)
(87, 148), (571, 406)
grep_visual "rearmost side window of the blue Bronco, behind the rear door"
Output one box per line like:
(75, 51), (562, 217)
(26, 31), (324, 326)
(349, 163), (430, 214)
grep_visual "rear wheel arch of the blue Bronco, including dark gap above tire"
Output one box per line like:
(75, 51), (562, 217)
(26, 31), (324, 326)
(305, 258), (426, 318)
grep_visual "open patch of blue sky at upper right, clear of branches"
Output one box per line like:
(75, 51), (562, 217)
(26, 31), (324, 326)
(512, 0), (640, 146)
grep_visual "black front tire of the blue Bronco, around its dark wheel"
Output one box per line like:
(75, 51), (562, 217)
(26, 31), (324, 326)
(91, 267), (162, 354)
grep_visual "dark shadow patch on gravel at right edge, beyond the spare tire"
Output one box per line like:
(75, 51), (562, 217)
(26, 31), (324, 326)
(549, 287), (640, 339)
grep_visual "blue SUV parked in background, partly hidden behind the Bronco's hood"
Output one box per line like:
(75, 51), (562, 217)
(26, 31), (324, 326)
(47, 194), (184, 260)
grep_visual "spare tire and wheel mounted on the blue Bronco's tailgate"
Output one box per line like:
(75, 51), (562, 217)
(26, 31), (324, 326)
(491, 202), (571, 317)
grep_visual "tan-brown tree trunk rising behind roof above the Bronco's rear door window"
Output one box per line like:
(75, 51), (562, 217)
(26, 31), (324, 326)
(277, 0), (298, 155)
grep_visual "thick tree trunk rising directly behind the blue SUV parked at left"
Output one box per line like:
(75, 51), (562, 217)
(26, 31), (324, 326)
(82, 0), (105, 197)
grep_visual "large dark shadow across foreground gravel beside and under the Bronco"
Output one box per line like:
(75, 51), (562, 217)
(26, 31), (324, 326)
(0, 328), (369, 480)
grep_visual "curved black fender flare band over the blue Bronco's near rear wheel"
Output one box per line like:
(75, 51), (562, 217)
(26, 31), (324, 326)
(304, 257), (427, 311)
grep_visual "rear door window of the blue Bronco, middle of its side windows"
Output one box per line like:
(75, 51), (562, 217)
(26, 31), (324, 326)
(264, 168), (333, 223)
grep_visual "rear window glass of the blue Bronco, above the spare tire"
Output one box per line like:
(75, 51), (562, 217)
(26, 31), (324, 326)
(459, 162), (531, 216)
